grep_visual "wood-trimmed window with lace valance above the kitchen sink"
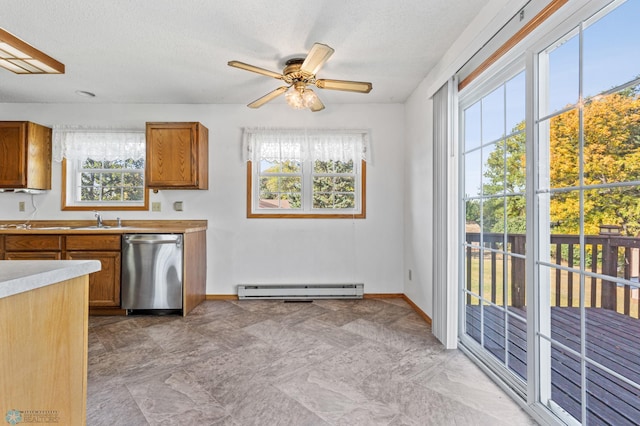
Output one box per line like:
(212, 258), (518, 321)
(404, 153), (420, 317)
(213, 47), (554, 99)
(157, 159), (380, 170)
(54, 129), (148, 210)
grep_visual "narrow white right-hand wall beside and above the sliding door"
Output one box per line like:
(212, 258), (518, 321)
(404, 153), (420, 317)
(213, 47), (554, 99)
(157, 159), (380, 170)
(403, 0), (526, 318)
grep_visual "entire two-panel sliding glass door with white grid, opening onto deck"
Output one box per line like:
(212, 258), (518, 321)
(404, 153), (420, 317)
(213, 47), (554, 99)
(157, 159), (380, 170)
(458, 0), (640, 425)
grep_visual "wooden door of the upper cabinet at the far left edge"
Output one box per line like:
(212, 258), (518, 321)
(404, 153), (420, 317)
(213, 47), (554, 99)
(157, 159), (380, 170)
(0, 121), (27, 188)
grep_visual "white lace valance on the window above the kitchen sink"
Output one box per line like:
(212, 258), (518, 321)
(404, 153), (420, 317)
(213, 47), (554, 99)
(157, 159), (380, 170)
(53, 126), (146, 162)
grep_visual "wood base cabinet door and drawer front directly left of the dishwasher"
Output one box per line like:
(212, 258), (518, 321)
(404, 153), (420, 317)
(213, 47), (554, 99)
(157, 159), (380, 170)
(67, 251), (120, 307)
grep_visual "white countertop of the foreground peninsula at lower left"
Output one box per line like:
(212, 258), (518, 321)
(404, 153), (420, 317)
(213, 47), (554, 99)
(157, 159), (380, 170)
(0, 260), (102, 298)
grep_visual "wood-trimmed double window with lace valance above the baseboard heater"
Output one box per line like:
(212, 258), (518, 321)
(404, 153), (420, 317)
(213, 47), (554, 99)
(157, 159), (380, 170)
(244, 129), (368, 218)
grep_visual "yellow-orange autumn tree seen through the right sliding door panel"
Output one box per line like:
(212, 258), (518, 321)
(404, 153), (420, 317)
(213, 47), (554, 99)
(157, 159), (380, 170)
(549, 88), (640, 236)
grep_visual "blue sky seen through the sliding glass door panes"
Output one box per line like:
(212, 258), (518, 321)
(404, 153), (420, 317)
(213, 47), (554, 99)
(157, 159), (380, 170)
(464, 0), (640, 199)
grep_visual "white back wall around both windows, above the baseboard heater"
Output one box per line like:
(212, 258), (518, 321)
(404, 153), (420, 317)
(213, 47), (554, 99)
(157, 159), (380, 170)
(0, 103), (405, 294)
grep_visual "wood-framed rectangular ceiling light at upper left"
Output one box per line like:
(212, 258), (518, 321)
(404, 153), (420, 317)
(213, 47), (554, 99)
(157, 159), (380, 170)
(0, 28), (65, 74)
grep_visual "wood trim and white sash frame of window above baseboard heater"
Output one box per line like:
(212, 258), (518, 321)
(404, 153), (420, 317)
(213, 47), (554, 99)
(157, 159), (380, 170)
(247, 160), (367, 219)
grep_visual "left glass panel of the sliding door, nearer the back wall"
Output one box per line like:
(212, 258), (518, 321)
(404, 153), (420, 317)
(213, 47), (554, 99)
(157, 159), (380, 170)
(461, 61), (527, 387)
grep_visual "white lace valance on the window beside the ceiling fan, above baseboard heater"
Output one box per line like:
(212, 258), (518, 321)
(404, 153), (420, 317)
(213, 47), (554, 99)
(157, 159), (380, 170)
(243, 129), (369, 162)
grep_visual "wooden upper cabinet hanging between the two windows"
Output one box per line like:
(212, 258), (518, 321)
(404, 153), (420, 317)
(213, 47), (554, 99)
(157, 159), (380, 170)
(145, 123), (209, 189)
